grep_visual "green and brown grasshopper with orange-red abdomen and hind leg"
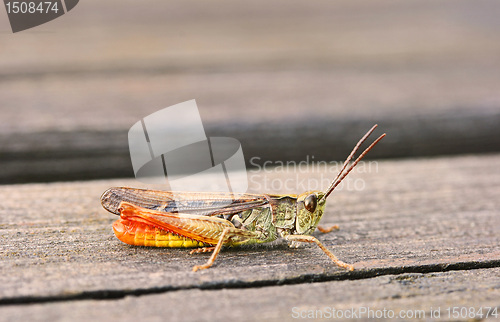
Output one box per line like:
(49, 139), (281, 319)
(101, 125), (385, 271)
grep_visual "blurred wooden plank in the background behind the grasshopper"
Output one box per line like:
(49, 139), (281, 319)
(0, 0), (500, 183)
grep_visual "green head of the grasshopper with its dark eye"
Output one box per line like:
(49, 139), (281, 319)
(295, 191), (326, 235)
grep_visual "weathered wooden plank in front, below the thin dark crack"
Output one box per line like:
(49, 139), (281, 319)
(0, 268), (500, 321)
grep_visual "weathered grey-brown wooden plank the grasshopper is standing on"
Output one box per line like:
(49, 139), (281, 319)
(0, 155), (500, 304)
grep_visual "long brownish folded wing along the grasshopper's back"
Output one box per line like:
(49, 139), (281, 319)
(101, 187), (269, 217)
